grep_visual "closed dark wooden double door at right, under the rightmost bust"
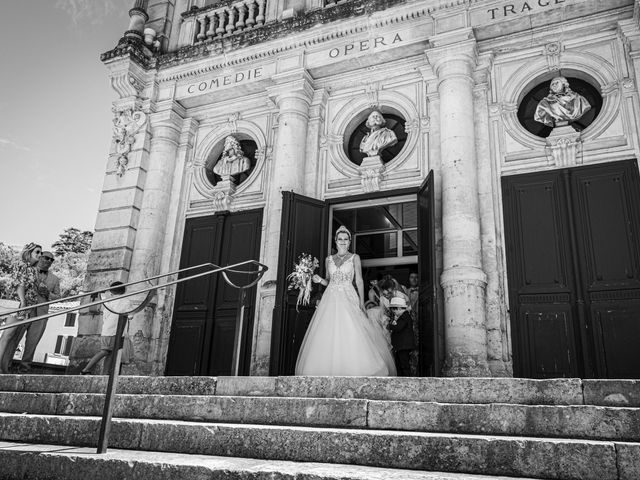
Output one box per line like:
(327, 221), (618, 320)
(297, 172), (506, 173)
(503, 161), (640, 378)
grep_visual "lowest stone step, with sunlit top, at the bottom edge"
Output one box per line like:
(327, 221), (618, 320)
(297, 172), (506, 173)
(0, 442), (544, 480)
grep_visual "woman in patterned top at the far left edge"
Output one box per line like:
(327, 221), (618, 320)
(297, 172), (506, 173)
(0, 243), (42, 373)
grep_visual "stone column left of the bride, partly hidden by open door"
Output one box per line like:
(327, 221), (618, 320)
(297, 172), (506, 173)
(251, 70), (313, 375)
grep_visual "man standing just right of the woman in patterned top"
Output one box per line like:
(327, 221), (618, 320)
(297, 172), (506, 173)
(18, 251), (60, 373)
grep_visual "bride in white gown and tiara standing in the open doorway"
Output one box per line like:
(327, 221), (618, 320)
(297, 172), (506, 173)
(296, 226), (396, 377)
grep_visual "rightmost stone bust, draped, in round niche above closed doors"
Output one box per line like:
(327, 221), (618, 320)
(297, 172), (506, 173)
(533, 77), (591, 127)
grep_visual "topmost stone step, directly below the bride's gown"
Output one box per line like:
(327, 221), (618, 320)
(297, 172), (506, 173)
(0, 375), (640, 407)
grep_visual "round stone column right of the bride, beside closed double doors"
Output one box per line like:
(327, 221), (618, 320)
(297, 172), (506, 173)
(426, 30), (490, 376)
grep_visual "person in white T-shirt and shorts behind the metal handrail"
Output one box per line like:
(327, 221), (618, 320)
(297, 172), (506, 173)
(80, 282), (131, 375)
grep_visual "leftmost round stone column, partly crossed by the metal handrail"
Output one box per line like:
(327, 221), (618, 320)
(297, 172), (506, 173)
(129, 106), (183, 374)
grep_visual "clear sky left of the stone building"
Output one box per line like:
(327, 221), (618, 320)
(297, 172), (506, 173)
(0, 0), (133, 248)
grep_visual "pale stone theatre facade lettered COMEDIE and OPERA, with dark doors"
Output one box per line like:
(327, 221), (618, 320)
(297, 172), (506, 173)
(71, 0), (640, 377)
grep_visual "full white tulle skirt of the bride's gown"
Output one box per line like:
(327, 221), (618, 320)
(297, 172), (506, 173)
(296, 284), (396, 377)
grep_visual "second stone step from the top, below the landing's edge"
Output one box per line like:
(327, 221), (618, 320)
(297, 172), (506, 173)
(0, 392), (640, 441)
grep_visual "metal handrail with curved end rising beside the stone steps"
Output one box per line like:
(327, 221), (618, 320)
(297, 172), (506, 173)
(0, 260), (268, 453)
